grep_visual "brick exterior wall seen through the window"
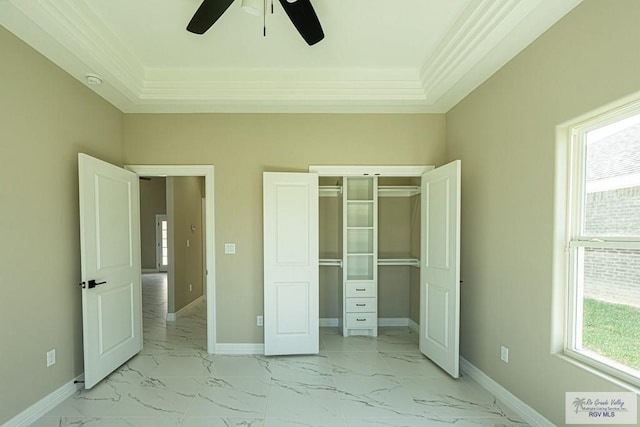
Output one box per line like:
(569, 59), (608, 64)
(584, 186), (640, 307)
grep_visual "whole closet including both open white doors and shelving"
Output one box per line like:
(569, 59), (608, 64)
(263, 160), (461, 377)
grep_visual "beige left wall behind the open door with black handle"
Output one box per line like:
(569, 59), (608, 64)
(0, 27), (123, 424)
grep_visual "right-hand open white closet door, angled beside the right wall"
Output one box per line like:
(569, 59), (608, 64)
(420, 160), (461, 378)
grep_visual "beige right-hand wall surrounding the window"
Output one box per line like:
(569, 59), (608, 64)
(447, 0), (640, 425)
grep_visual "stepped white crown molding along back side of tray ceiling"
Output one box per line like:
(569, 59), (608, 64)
(140, 70), (424, 102)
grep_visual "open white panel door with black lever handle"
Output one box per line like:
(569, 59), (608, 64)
(78, 154), (142, 388)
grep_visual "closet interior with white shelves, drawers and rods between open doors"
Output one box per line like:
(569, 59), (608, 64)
(319, 176), (420, 336)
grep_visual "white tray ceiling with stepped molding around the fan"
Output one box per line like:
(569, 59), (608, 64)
(0, 0), (581, 112)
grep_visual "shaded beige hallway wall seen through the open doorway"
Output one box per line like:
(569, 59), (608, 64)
(170, 176), (204, 312)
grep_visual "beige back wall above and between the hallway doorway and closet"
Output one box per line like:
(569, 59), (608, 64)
(124, 114), (445, 343)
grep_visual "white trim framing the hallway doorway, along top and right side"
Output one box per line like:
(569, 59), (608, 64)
(125, 165), (216, 354)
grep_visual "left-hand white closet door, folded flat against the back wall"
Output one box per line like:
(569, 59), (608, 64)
(263, 172), (320, 355)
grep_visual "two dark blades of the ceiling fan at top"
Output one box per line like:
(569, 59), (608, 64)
(187, 0), (324, 46)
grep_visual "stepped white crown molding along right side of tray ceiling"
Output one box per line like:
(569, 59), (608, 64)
(420, 0), (583, 111)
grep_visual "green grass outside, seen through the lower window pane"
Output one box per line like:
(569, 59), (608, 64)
(582, 298), (640, 370)
